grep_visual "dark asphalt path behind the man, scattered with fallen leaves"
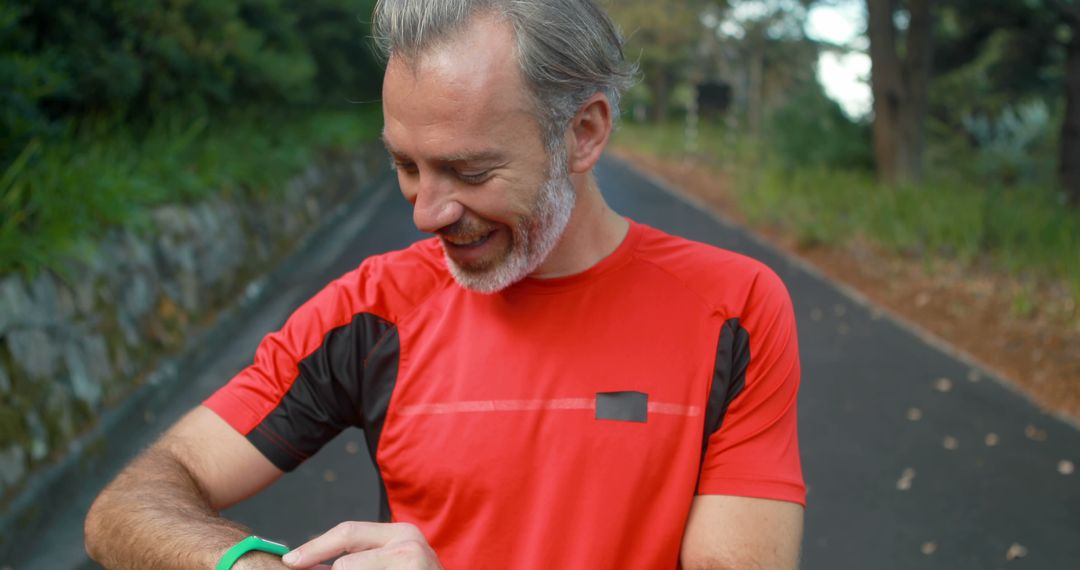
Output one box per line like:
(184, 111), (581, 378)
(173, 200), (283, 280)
(10, 153), (1080, 570)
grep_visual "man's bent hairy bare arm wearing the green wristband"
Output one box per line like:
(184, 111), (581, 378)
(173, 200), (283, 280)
(85, 406), (285, 569)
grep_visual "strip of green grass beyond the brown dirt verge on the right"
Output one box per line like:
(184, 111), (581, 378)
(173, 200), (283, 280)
(616, 120), (1080, 304)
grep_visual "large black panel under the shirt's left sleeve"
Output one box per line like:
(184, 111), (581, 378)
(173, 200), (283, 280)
(247, 313), (400, 477)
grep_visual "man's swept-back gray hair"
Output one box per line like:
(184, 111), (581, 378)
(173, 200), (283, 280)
(373, 0), (637, 157)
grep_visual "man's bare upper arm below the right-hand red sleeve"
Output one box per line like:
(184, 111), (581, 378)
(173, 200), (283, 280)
(681, 494), (804, 570)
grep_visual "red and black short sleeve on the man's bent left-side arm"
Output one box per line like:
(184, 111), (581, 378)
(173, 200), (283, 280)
(204, 260), (393, 471)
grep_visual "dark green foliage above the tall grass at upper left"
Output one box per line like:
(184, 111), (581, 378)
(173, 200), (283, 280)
(0, 0), (380, 165)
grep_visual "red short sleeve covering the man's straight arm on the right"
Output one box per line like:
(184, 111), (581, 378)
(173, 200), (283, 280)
(698, 267), (806, 505)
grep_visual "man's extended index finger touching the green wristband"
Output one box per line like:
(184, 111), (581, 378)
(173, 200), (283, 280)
(282, 521), (423, 568)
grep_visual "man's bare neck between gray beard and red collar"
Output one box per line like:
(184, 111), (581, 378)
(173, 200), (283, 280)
(529, 174), (630, 279)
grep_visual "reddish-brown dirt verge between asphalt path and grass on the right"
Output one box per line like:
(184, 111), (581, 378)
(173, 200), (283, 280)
(612, 148), (1080, 423)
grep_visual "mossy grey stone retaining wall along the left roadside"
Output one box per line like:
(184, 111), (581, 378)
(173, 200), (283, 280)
(0, 151), (381, 505)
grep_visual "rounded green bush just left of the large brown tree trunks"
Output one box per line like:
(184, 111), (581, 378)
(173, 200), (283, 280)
(766, 84), (874, 169)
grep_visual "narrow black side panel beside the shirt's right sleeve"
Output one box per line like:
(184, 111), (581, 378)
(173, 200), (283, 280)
(701, 318), (750, 461)
